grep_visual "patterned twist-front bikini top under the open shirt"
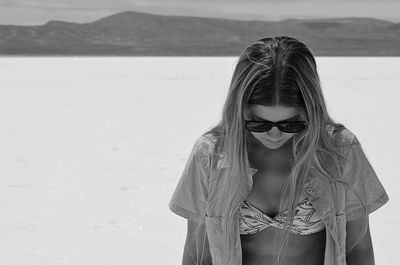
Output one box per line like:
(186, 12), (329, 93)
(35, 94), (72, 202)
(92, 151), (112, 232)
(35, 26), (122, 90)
(239, 198), (325, 235)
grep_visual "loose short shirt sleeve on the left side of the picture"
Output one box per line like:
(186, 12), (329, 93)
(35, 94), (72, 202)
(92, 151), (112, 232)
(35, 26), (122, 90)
(169, 136), (210, 222)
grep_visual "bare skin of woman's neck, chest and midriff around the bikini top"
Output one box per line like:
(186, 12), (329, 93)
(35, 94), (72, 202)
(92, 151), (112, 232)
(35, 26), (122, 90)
(240, 148), (326, 264)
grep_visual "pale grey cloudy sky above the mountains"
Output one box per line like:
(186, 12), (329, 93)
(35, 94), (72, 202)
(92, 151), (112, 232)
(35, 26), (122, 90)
(0, 0), (400, 25)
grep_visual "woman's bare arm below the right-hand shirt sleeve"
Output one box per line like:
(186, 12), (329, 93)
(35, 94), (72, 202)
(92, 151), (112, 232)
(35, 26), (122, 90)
(346, 218), (375, 265)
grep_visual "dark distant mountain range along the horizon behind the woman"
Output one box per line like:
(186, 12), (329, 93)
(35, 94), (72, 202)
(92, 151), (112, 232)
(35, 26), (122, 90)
(0, 11), (400, 56)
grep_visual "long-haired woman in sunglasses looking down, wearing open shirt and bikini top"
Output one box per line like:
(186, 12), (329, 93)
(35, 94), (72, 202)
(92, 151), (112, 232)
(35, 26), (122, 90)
(169, 36), (388, 265)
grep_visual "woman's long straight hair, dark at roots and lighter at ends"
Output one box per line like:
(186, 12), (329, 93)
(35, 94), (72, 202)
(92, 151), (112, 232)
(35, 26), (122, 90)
(186, 36), (367, 265)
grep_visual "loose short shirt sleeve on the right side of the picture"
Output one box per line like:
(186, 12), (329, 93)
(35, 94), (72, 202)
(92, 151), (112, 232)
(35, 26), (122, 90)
(343, 135), (389, 221)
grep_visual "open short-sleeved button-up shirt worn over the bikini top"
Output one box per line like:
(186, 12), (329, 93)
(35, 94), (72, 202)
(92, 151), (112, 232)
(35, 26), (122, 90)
(169, 126), (389, 265)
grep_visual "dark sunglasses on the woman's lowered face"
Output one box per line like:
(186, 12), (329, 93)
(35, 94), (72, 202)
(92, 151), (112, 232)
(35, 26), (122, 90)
(245, 120), (307, 133)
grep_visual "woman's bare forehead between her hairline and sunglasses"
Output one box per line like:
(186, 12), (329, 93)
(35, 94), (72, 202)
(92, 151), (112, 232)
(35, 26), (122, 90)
(247, 104), (299, 122)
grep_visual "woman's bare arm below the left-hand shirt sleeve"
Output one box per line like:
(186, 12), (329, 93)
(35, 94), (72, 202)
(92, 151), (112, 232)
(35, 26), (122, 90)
(182, 220), (212, 265)
